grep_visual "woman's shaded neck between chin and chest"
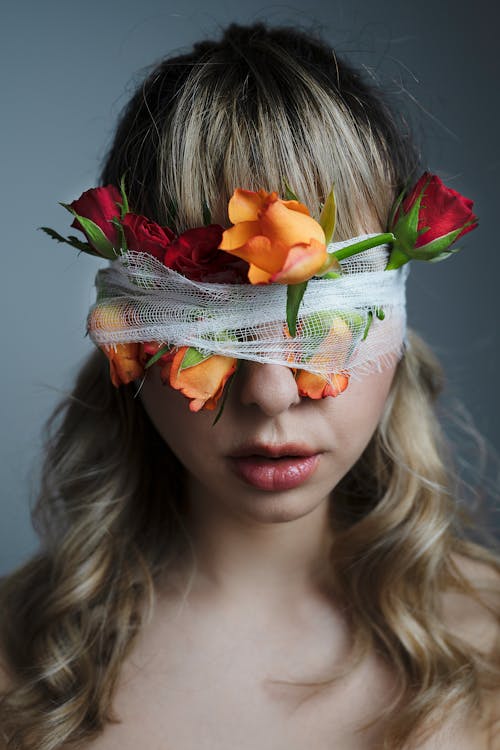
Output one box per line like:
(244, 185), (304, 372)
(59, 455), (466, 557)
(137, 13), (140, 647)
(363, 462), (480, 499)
(174, 481), (331, 607)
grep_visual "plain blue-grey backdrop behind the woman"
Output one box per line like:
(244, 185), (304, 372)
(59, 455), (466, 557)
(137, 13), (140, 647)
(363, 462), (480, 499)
(0, 0), (500, 572)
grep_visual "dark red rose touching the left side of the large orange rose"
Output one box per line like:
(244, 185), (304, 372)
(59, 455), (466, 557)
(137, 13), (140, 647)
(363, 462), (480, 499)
(162, 224), (248, 284)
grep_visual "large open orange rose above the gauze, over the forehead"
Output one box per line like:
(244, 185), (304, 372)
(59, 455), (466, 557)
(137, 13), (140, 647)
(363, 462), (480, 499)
(219, 188), (328, 284)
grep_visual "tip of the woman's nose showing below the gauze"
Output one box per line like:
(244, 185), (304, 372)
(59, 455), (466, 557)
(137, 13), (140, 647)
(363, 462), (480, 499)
(238, 360), (300, 417)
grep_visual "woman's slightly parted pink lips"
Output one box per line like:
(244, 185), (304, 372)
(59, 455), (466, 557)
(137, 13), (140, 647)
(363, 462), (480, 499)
(229, 443), (320, 492)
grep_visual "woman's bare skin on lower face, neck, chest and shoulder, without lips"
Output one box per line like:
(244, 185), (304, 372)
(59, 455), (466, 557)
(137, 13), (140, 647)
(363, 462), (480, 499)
(0, 363), (498, 750)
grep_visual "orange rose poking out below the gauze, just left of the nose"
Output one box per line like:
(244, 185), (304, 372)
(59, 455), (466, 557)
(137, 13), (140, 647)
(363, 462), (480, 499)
(160, 346), (236, 411)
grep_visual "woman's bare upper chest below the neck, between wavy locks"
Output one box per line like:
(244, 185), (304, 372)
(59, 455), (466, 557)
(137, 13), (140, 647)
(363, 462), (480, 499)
(88, 604), (391, 750)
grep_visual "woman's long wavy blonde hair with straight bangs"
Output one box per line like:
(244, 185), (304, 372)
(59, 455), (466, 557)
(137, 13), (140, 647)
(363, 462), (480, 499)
(0, 24), (500, 750)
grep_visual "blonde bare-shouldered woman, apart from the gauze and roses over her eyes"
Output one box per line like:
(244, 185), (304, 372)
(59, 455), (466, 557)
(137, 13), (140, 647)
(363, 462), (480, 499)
(0, 24), (500, 750)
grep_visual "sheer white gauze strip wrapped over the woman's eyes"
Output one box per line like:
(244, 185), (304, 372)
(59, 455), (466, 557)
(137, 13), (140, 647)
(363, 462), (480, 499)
(88, 235), (409, 380)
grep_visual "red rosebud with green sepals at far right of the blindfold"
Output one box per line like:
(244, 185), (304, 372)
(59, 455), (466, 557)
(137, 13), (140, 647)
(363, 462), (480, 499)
(386, 172), (478, 270)
